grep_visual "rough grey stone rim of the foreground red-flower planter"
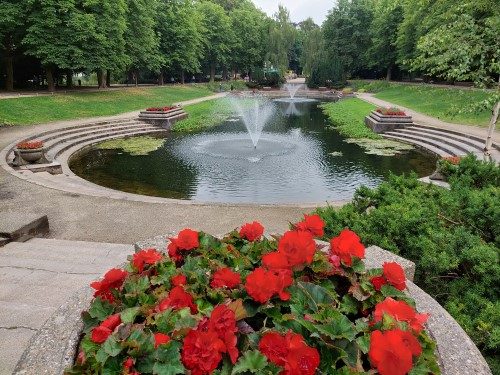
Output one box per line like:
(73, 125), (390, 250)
(14, 247), (492, 375)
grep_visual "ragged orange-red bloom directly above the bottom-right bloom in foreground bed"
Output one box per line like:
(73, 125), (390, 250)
(373, 297), (429, 333)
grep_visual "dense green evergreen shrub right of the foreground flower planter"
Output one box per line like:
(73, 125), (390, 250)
(318, 156), (500, 373)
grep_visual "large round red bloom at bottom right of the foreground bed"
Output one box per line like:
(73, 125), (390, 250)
(368, 329), (422, 375)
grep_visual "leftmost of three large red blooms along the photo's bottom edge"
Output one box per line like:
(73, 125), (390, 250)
(182, 305), (239, 375)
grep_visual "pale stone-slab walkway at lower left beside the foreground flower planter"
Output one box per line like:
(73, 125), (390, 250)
(0, 238), (133, 375)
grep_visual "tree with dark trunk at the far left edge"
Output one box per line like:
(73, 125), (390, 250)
(0, 0), (25, 91)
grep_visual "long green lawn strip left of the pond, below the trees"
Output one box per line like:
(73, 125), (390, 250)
(0, 85), (213, 125)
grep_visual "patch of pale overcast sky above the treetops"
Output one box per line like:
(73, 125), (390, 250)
(253, 0), (335, 25)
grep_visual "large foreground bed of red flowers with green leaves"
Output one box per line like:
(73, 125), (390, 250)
(67, 215), (439, 375)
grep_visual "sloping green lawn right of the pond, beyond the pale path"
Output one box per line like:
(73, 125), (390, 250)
(352, 81), (499, 126)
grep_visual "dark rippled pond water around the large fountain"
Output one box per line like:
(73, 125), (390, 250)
(70, 102), (436, 204)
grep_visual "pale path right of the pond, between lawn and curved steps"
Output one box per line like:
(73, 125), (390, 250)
(356, 93), (500, 143)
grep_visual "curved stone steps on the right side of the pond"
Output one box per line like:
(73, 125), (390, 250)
(382, 124), (500, 162)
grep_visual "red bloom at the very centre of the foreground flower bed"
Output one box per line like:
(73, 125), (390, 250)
(245, 267), (293, 303)
